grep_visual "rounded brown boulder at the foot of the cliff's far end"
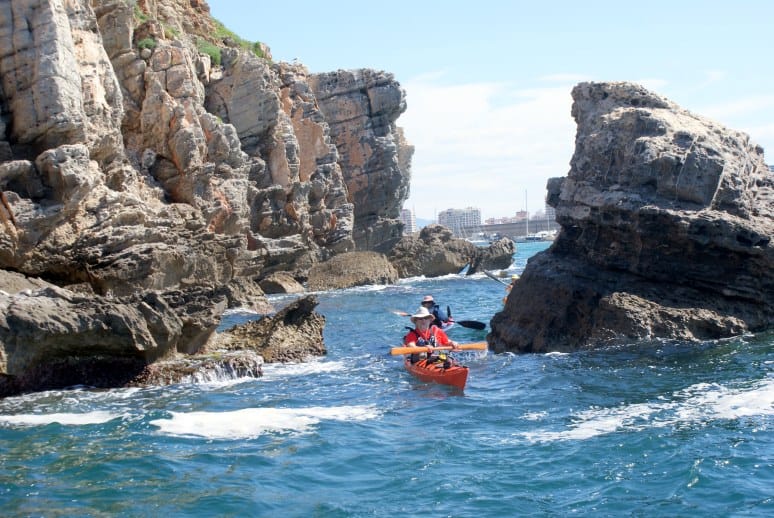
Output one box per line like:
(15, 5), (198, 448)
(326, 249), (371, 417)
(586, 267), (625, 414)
(307, 252), (398, 291)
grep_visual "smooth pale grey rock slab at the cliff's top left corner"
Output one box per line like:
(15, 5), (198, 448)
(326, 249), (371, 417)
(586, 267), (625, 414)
(0, 0), (123, 161)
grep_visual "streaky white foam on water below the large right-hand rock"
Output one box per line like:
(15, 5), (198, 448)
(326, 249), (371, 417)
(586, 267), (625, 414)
(520, 379), (774, 442)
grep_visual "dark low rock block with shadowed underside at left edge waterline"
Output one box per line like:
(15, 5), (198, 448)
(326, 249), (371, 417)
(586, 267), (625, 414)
(0, 287), (185, 396)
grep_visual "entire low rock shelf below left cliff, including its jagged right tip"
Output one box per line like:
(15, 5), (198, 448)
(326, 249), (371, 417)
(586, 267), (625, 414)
(0, 272), (325, 397)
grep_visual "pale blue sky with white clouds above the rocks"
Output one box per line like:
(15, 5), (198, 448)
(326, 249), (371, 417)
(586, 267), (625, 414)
(208, 0), (774, 219)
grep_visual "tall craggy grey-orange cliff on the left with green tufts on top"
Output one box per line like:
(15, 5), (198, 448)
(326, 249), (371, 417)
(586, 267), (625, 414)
(0, 0), (411, 396)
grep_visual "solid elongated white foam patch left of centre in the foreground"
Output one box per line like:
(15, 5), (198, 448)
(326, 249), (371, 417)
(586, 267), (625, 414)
(151, 406), (378, 439)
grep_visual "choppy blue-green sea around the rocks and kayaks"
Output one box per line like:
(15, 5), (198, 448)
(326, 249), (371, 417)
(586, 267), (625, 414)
(0, 242), (774, 518)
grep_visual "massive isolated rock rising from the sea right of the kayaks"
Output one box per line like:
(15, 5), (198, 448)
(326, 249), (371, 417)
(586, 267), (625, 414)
(488, 83), (774, 352)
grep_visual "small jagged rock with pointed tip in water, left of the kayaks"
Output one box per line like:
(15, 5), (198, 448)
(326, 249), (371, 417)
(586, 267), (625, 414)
(214, 295), (327, 363)
